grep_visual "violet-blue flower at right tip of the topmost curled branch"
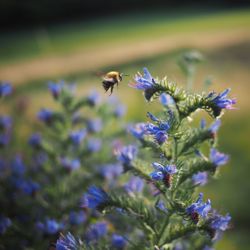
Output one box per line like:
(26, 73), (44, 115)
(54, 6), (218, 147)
(207, 89), (236, 109)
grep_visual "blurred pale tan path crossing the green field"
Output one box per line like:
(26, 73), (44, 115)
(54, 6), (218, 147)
(0, 28), (250, 85)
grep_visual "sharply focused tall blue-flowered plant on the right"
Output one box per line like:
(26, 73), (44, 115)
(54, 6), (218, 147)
(73, 69), (235, 249)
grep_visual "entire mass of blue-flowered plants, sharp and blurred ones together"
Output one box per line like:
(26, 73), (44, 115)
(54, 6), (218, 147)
(0, 64), (235, 250)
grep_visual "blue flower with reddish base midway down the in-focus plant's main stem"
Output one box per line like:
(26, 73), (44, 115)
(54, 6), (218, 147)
(150, 162), (177, 187)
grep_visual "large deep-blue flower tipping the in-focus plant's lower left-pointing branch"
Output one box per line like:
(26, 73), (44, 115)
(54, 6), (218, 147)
(81, 186), (109, 209)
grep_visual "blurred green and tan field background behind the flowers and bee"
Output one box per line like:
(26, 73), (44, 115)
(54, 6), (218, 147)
(0, 1), (250, 250)
